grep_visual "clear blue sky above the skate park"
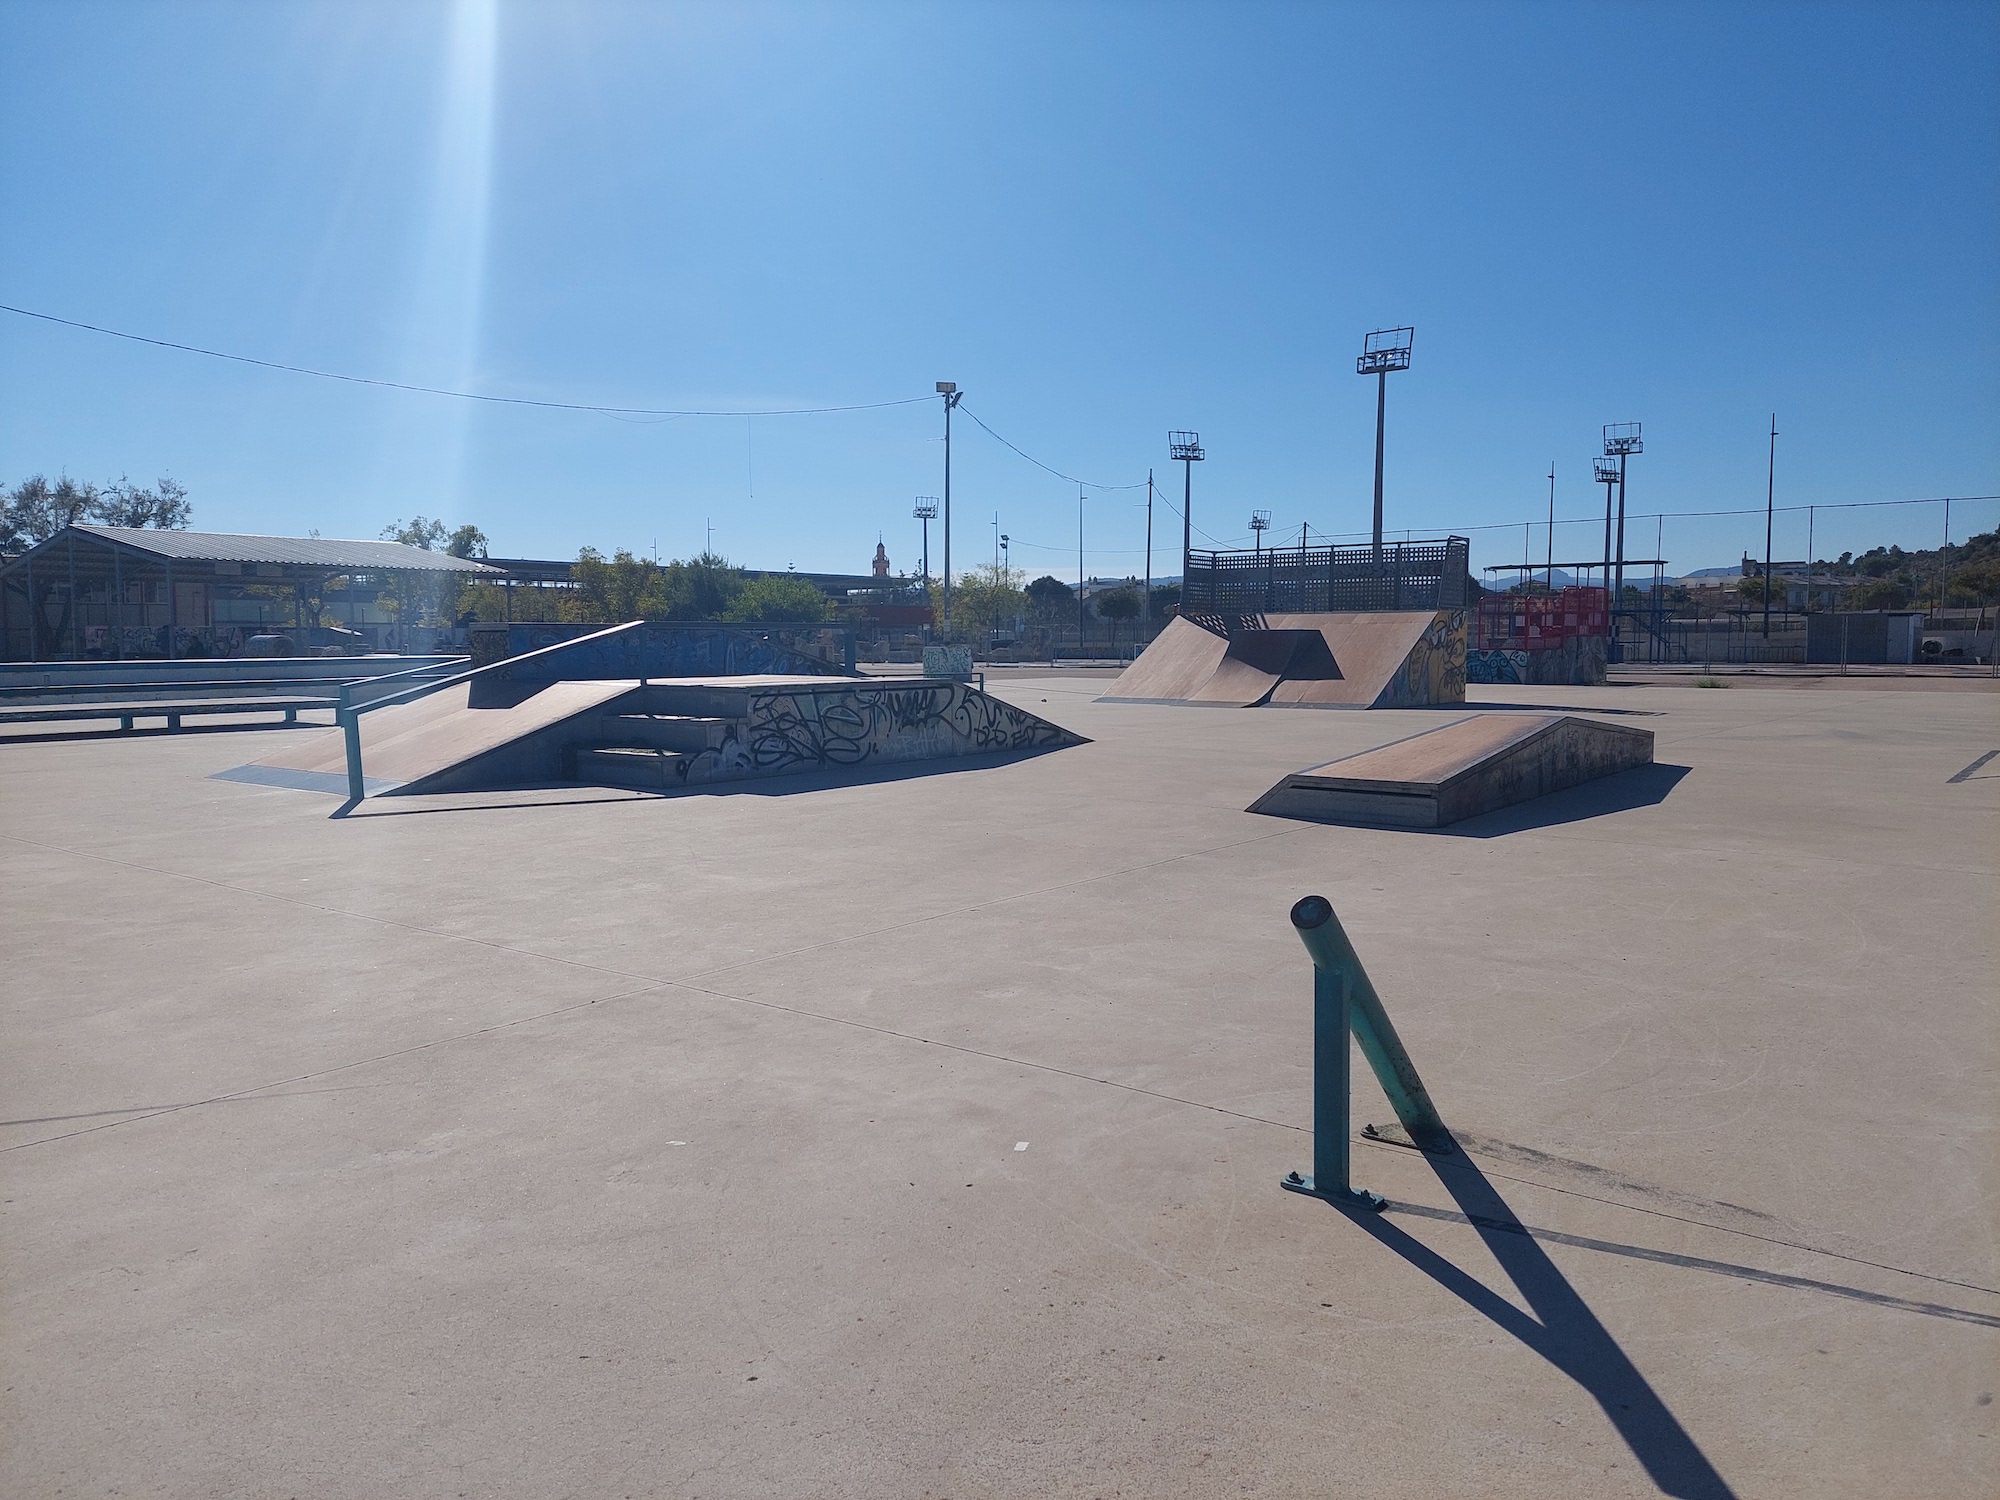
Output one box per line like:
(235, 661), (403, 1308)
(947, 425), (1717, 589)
(0, 0), (2000, 576)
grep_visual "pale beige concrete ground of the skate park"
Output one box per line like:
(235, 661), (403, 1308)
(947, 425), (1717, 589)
(0, 670), (2000, 1500)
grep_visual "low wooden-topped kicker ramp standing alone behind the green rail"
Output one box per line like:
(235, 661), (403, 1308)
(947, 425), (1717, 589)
(1248, 714), (1652, 828)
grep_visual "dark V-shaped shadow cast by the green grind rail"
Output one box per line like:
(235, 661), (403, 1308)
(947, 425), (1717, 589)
(1340, 1146), (1736, 1500)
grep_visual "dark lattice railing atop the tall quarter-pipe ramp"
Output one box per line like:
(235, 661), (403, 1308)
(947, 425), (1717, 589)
(1182, 536), (1472, 614)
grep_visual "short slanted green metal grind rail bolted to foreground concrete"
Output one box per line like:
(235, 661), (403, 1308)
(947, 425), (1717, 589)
(1278, 896), (1452, 1210)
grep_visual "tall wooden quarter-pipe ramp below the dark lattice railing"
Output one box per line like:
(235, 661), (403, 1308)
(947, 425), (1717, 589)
(1102, 610), (1466, 708)
